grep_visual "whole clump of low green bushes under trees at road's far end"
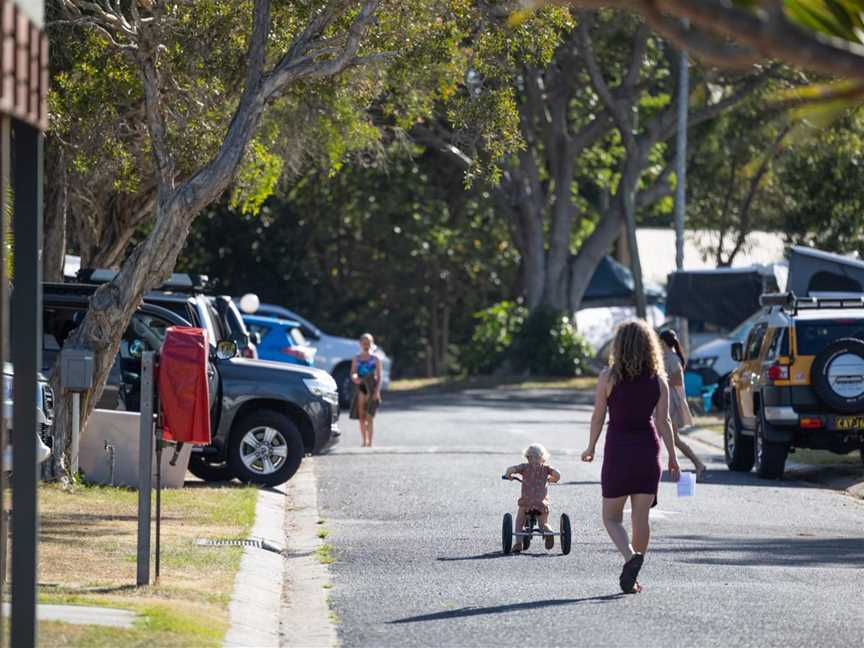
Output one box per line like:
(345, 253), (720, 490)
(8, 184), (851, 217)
(462, 301), (592, 377)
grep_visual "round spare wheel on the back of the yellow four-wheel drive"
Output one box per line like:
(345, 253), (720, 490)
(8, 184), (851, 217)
(810, 338), (864, 414)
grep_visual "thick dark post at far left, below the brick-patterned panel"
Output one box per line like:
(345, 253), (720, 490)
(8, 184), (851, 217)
(11, 121), (43, 648)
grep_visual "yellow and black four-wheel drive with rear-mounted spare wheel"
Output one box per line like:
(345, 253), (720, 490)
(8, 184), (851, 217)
(724, 293), (864, 479)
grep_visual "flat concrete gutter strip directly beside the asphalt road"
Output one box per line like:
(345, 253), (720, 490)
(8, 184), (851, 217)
(280, 458), (339, 648)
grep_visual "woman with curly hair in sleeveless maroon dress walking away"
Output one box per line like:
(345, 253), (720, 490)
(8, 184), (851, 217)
(582, 320), (680, 594)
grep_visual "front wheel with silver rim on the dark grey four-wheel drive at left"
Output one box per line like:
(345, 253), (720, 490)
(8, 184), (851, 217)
(228, 410), (305, 486)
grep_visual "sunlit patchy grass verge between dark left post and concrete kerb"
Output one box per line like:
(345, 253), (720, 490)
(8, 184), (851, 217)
(31, 482), (257, 648)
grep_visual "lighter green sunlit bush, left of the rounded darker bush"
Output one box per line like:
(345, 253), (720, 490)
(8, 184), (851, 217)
(462, 301), (528, 374)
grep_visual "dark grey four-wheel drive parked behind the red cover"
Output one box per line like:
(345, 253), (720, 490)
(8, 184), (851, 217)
(43, 284), (339, 486)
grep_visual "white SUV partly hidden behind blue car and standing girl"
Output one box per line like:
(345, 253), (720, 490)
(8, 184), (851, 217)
(237, 299), (393, 407)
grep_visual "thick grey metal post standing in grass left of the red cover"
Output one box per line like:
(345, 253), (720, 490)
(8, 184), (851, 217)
(135, 351), (155, 587)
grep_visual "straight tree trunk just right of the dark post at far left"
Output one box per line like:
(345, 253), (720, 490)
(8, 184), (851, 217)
(42, 136), (69, 281)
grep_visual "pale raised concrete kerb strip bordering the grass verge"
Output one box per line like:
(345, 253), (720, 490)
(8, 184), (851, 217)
(224, 485), (289, 648)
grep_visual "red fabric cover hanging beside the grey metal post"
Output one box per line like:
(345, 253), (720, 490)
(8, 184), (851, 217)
(159, 326), (210, 445)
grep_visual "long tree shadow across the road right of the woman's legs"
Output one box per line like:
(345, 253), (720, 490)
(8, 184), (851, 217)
(652, 534), (864, 569)
